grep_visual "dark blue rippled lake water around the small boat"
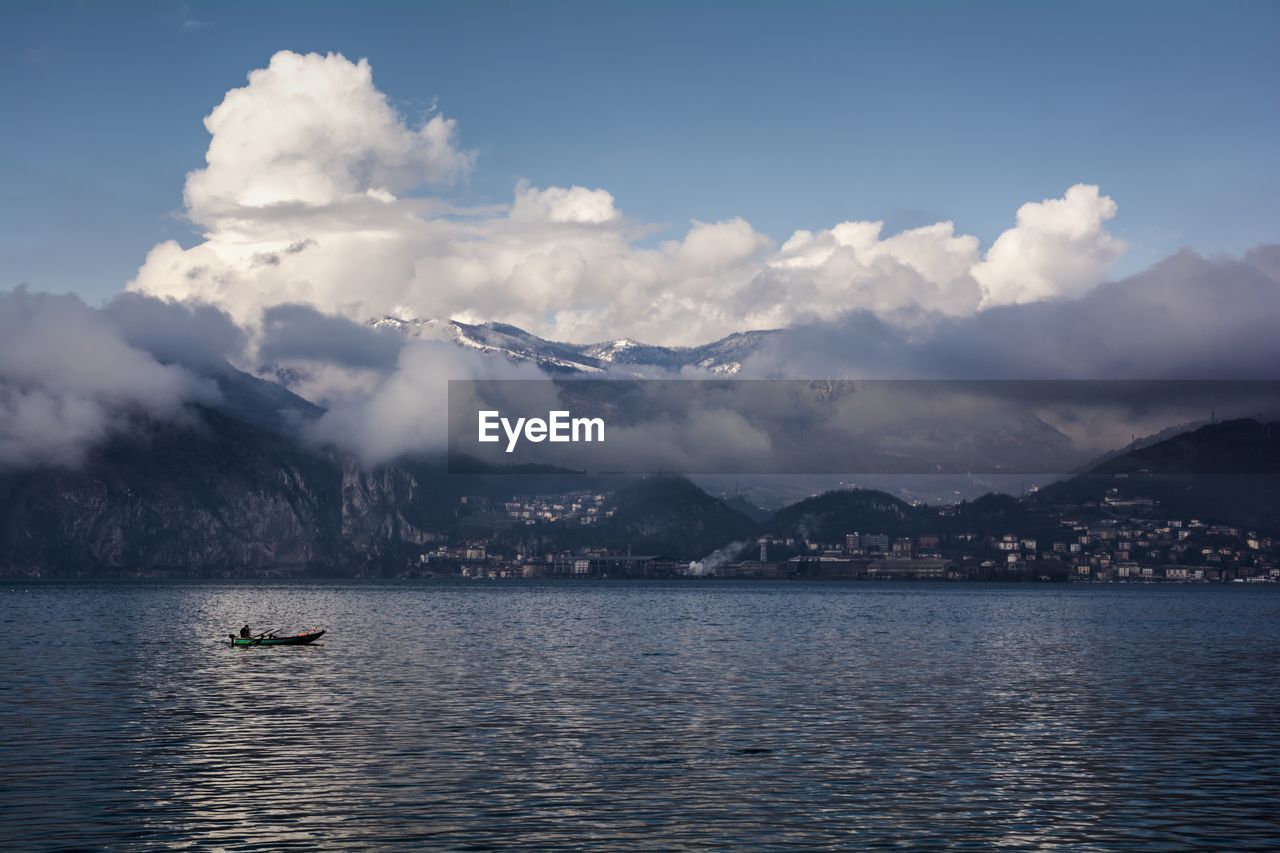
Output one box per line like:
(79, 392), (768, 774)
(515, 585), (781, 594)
(0, 581), (1280, 849)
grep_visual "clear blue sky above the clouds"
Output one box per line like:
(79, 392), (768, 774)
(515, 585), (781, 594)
(0, 3), (1280, 300)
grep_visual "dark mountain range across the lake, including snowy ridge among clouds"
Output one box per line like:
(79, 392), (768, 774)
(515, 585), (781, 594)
(0, 333), (1280, 576)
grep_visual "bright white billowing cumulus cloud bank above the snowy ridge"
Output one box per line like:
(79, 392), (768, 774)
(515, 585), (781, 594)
(131, 51), (1124, 345)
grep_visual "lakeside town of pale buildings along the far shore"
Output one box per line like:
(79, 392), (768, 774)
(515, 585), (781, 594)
(397, 481), (1280, 583)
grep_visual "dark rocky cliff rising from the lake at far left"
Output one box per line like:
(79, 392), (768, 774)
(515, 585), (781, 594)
(0, 397), (471, 576)
